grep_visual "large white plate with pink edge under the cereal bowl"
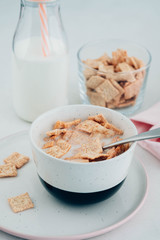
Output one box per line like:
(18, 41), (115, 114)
(0, 131), (147, 240)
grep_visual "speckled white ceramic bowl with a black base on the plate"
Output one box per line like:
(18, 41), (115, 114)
(30, 105), (137, 201)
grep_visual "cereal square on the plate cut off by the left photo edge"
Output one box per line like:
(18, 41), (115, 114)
(0, 163), (17, 178)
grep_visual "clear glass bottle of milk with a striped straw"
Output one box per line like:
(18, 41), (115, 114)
(12, 0), (68, 122)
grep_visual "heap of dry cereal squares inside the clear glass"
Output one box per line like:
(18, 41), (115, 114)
(83, 49), (145, 108)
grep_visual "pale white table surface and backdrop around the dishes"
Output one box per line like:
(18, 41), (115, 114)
(0, 0), (160, 240)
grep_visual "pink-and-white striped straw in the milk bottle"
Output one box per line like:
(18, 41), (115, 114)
(39, 3), (50, 57)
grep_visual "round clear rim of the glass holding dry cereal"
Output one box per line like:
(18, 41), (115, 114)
(77, 38), (152, 75)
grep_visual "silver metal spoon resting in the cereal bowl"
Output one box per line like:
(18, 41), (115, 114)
(102, 128), (160, 151)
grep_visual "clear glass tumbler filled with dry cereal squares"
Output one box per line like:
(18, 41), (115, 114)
(77, 39), (151, 116)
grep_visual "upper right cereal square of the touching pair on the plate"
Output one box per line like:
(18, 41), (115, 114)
(4, 152), (29, 168)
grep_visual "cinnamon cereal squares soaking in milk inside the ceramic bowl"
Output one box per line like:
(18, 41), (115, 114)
(42, 114), (129, 163)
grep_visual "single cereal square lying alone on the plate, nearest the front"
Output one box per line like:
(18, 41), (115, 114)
(8, 192), (34, 213)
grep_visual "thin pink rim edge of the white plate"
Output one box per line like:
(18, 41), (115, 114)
(0, 130), (148, 240)
